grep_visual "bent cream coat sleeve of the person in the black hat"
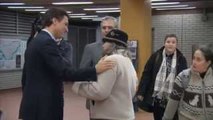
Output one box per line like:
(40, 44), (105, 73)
(72, 57), (117, 101)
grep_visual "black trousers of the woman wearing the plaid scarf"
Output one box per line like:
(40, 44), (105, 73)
(153, 99), (178, 120)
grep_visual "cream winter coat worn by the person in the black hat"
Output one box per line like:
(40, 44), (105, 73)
(73, 54), (138, 120)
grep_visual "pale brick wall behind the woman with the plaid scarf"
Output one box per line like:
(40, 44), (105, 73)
(152, 13), (213, 66)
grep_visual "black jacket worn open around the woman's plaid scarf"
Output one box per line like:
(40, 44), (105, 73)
(137, 47), (187, 112)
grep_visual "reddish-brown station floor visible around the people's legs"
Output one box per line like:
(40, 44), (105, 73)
(0, 83), (153, 120)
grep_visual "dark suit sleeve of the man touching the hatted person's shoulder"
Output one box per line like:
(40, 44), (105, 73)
(39, 40), (97, 81)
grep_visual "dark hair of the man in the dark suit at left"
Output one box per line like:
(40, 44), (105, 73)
(43, 8), (69, 27)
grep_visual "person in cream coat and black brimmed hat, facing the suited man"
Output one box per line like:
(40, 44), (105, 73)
(72, 29), (138, 120)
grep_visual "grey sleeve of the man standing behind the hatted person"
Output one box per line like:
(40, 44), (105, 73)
(80, 45), (92, 68)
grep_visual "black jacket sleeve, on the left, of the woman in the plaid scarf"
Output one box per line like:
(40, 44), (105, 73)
(137, 55), (155, 96)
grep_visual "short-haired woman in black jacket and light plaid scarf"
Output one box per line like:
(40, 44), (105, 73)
(137, 34), (187, 120)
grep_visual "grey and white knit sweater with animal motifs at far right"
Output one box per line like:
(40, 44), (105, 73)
(165, 68), (213, 120)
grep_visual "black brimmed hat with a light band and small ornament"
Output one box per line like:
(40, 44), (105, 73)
(103, 29), (128, 47)
